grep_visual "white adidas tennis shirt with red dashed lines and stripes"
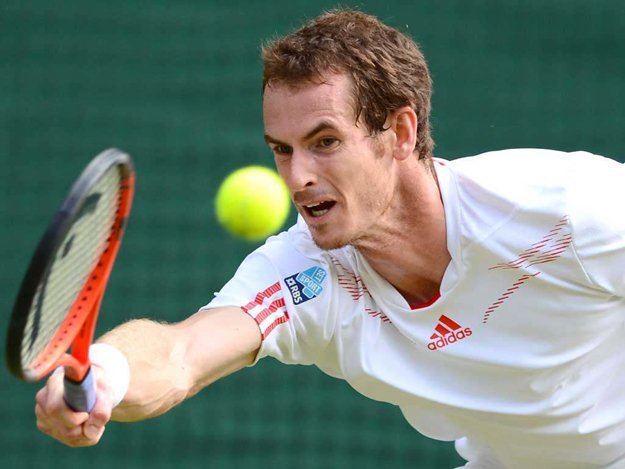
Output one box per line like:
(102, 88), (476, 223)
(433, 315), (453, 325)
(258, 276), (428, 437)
(207, 149), (625, 469)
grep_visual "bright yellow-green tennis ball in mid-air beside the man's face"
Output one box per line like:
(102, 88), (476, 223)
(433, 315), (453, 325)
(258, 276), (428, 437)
(215, 166), (291, 241)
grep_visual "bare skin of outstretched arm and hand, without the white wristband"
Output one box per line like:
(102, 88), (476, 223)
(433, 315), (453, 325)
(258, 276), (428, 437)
(35, 307), (261, 446)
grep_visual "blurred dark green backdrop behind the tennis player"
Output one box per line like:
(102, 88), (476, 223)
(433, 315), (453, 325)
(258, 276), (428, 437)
(0, 0), (625, 469)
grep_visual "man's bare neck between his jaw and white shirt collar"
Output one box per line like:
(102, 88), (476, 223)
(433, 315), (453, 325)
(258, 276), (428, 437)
(354, 157), (451, 304)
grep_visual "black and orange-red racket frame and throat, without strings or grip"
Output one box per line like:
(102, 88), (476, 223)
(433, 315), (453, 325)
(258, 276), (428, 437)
(6, 149), (135, 383)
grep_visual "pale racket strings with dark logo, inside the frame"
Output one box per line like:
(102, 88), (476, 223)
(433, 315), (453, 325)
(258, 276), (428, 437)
(21, 166), (121, 366)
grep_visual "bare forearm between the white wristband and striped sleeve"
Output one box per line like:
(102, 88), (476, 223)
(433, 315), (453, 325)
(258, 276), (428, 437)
(98, 308), (260, 421)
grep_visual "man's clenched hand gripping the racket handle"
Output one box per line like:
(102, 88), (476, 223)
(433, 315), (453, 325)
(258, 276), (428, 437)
(35, 365), (113, 448)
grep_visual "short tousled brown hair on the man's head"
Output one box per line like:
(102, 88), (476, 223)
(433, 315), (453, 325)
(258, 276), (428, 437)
(262, 9), (434, 159)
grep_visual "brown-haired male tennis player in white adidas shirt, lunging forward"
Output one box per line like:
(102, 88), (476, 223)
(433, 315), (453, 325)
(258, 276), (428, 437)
(36, 10), (625, 469)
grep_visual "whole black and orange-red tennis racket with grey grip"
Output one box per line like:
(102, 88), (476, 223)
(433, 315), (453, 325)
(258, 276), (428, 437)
(6, 149), (135, 412)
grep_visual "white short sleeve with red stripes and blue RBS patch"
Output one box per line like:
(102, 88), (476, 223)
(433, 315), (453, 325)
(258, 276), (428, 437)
(202, 234), (336, 364)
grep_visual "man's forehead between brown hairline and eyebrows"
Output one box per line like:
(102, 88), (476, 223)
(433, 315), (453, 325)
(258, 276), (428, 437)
(263, 75), (355, 137)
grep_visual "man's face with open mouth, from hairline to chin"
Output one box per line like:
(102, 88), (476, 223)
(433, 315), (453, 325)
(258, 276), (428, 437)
(263, 75), (394, 249)
